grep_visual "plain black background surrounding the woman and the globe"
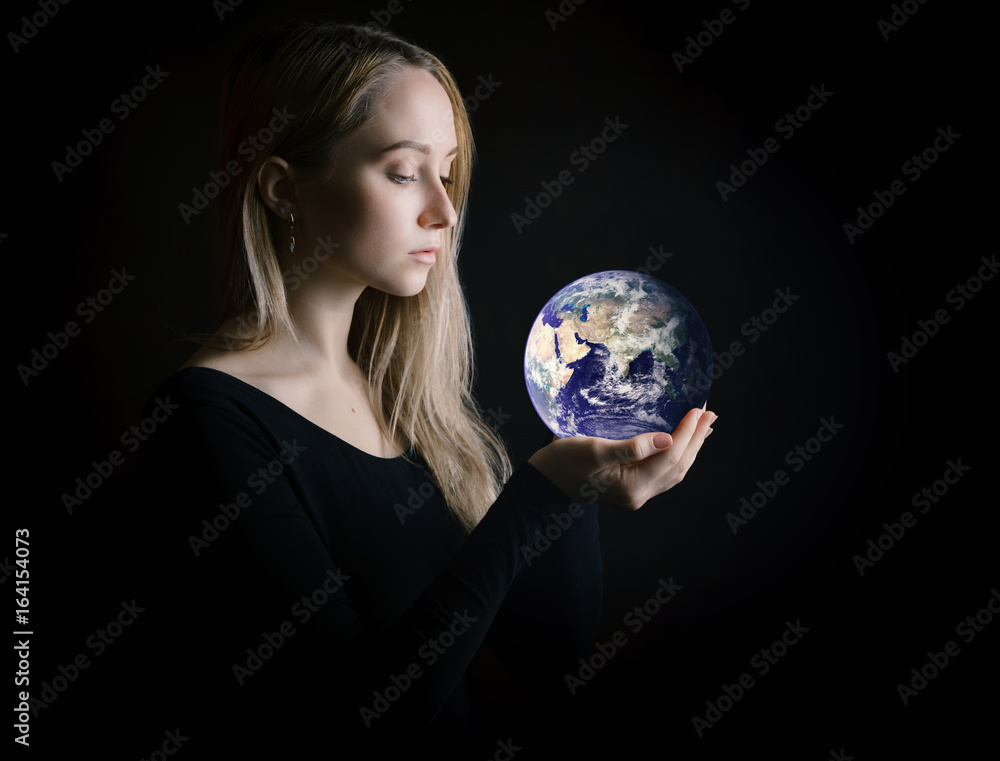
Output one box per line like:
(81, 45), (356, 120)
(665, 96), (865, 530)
(0, 0), (1000, 759)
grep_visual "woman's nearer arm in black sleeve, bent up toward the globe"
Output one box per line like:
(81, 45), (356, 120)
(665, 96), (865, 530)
(131, 394), (580, 748)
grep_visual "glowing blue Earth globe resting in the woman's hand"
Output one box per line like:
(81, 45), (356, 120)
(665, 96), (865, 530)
(524, 270), (712, 440)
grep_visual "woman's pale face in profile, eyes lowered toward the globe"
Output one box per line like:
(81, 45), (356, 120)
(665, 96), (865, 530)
(294, 66), (458, 296)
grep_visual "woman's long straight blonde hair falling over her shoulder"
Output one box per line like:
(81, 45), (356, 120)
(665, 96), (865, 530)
(209, 22), (511, 531)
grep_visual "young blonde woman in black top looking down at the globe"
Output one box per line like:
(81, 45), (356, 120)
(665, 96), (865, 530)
(140, 17), (715, 758)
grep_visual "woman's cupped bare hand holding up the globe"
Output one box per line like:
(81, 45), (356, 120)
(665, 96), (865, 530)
(528, 402), (718, 510)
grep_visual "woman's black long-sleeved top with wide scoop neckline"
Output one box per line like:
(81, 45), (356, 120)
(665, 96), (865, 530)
(132, 367), (602, 757)
